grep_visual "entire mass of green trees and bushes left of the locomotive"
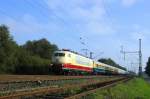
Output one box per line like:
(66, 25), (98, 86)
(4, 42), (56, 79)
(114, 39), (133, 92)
(0, 25), (58, 74)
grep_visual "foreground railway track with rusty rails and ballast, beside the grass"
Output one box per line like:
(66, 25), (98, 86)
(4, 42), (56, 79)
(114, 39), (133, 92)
(0, 76), (131, 99)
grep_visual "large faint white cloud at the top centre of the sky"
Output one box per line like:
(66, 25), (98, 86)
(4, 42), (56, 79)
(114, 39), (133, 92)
(45, 0), (115, 35)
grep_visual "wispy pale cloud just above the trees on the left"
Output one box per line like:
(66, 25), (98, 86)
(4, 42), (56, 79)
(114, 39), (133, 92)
(0, 14), (60, 35)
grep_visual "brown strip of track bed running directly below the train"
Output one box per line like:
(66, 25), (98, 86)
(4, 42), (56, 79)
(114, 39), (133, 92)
(0, 75), (113, 84)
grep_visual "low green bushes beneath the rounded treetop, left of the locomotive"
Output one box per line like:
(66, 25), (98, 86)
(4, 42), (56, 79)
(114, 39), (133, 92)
(15, 49), (50, 74)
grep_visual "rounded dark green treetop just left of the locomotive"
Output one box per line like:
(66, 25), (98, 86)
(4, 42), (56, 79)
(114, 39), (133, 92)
(23, 39), (58, 59)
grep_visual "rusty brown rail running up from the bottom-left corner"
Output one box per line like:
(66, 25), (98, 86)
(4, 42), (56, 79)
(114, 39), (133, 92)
(0, 77), (126, 99)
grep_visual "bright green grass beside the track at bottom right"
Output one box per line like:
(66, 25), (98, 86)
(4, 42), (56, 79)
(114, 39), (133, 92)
(89, 78), (150, 99)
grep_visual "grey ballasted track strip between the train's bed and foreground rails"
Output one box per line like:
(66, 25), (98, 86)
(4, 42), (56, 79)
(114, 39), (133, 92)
(0, 76), (113, 94)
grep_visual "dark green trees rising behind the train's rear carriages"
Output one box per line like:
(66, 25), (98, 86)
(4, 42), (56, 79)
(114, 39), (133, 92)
(98, 58), (126, 70)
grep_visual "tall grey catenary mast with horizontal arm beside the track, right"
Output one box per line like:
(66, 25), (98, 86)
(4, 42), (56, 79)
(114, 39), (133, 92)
(120, 39), (142, 76)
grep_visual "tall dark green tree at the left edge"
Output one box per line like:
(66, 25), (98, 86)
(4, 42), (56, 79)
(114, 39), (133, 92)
(0, 25), (17, 73)
